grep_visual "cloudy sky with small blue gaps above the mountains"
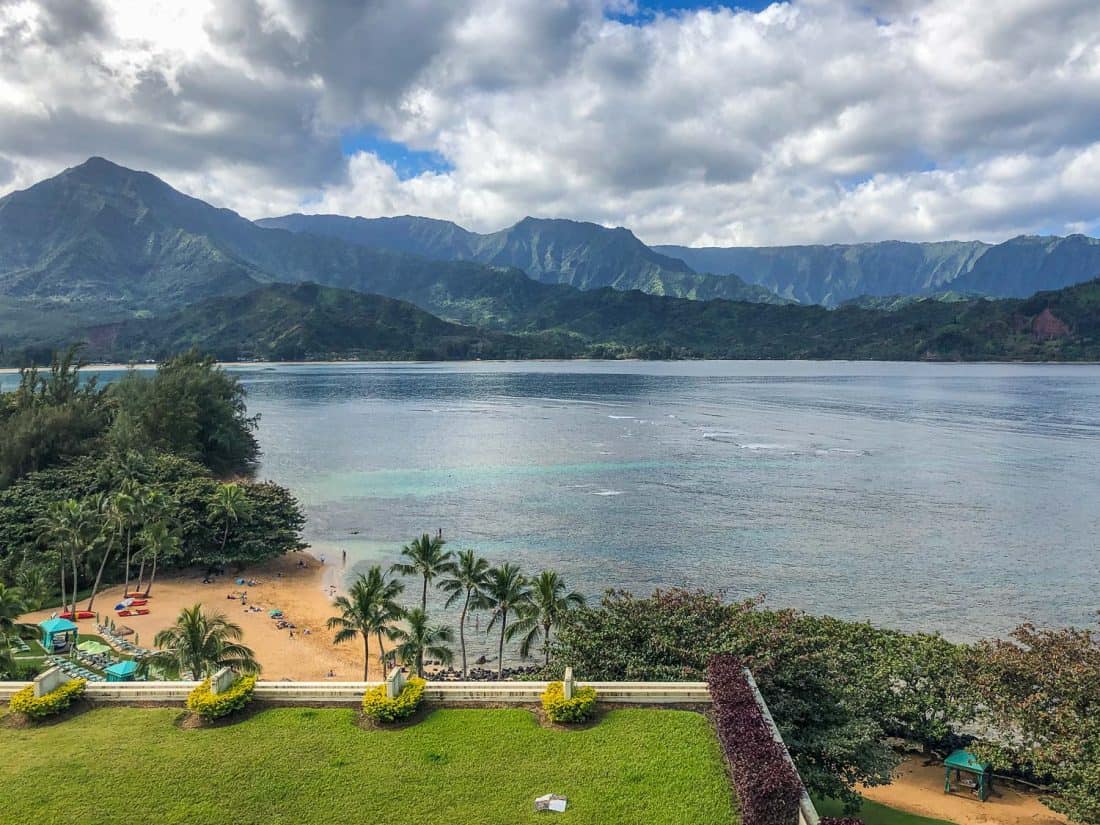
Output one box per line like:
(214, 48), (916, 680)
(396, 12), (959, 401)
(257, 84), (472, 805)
(0, 0), (1100, 245)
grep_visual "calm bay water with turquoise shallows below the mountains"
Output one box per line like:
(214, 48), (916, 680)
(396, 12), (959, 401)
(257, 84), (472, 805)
(4, 362), (1100, 638)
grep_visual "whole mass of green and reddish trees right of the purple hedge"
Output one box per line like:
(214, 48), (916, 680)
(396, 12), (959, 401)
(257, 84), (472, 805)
(553, 591), (1100, 825)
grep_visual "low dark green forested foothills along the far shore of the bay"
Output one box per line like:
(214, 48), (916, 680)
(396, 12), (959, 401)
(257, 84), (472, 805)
(40, 279), (1100, 361)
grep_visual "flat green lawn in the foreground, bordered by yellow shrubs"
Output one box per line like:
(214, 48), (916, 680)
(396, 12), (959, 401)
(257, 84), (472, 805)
(0, 707), (737, 825)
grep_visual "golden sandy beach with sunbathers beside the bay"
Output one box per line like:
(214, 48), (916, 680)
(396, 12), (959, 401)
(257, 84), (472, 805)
(21, 553), (381, 681)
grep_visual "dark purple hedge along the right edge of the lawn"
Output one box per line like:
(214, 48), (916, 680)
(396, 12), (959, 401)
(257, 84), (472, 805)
(706, 653), (802, 825)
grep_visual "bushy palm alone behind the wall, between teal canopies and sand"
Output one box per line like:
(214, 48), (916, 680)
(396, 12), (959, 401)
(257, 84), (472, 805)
(149, 604), (260, 679)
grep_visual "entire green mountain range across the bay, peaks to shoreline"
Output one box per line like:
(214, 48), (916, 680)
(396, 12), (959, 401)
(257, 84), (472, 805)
(0, 158), (1100, 364)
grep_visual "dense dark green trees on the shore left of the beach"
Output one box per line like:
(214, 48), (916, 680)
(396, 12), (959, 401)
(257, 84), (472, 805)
(0, 350), (305, 609)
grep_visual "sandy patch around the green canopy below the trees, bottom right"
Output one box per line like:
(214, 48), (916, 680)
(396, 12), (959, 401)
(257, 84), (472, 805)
(861, 758), (1068, 825)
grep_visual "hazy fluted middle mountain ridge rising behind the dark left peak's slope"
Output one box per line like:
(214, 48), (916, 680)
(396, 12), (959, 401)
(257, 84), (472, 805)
(256, 215), (792, 304)
